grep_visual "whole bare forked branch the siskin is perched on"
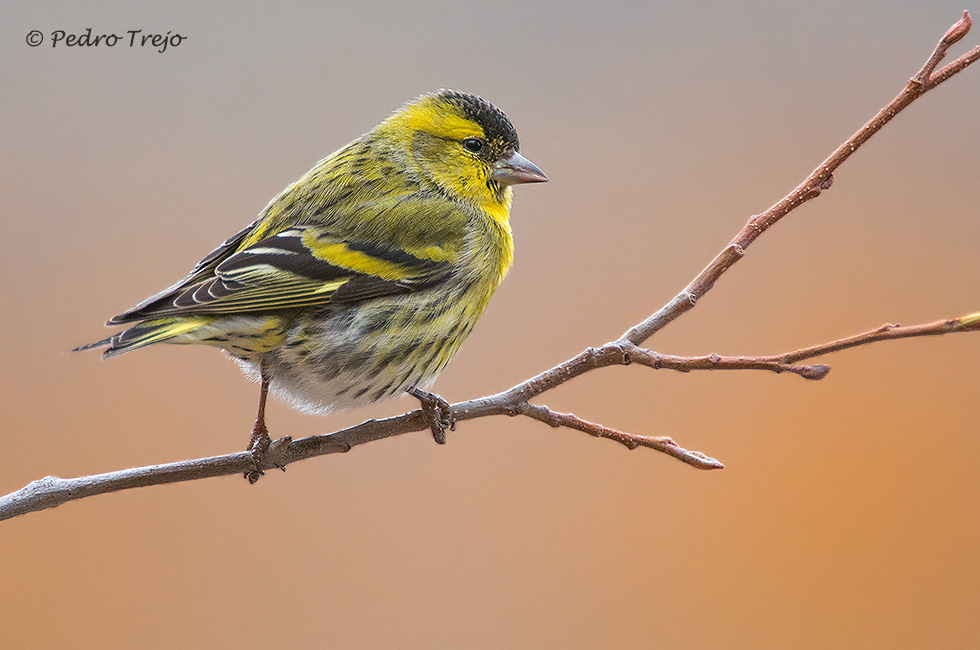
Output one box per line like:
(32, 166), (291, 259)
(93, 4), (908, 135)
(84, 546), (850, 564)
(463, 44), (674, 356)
(0, 12), (980, 520)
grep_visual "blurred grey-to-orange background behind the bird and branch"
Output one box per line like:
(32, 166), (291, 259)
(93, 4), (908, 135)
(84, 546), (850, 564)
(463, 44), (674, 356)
(0, 0), (980, 649)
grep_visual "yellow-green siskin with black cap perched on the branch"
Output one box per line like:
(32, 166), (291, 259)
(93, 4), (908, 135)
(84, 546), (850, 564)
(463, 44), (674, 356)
(73, 90), (548, 470)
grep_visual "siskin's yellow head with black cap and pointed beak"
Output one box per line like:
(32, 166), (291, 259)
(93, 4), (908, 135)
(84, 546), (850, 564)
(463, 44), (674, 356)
(380, 90), (548, 210)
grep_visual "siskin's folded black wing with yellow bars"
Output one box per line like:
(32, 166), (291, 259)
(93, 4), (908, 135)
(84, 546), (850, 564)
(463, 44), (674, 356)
(109, 225), (458, 325)
